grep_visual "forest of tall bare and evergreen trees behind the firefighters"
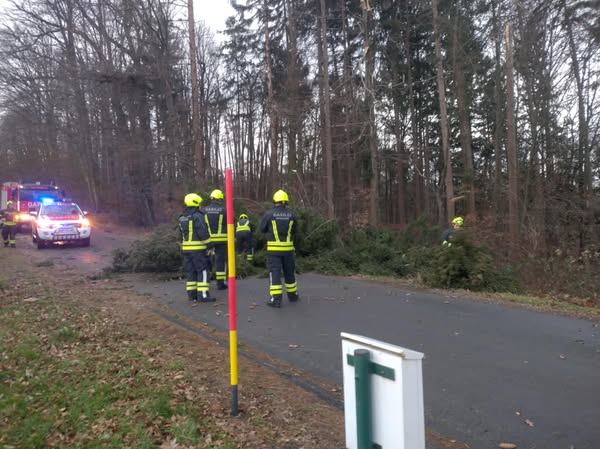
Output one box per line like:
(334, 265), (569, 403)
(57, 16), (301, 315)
(0, 0), (600, 304)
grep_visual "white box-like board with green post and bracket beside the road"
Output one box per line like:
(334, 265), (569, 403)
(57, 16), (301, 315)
(341, 332), (425, 449)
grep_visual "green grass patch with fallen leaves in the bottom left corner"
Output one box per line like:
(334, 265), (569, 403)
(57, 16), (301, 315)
(0, 300), (236, 449)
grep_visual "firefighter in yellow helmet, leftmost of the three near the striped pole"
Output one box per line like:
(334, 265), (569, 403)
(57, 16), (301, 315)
(178, 193), (216, 302)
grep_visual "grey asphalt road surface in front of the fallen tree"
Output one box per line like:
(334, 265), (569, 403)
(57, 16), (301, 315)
(130, 274), (600, 449)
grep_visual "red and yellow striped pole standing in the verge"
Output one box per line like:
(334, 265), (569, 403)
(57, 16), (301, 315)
(225, 168), (238, 416)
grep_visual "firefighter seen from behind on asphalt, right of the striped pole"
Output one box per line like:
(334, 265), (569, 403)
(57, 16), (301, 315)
(259, 190), (299, 308)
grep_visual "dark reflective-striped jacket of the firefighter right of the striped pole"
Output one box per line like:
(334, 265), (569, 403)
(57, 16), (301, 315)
(259, 204), (298, 252)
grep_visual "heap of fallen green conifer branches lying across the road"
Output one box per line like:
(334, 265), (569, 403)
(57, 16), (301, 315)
(112, 206), (595, 295)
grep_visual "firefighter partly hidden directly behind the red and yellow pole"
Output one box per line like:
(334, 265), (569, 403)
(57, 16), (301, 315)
(202, 189), (227, 290)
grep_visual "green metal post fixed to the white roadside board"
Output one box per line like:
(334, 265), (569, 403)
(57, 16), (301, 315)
(354, 349), (373, 449)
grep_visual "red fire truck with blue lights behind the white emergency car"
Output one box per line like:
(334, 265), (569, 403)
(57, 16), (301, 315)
(0, 181), (65, 231)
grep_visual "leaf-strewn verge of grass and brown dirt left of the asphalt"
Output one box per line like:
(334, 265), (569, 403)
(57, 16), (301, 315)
(0, 248), (344, 449)
